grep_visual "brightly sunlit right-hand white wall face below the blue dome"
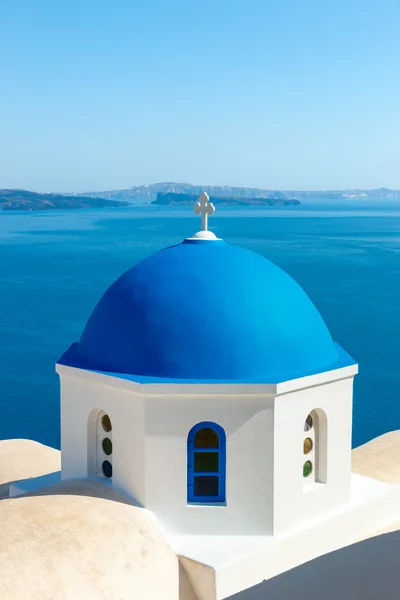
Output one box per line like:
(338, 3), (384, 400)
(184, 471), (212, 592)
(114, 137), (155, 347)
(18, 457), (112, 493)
(274, 375), (353, 533)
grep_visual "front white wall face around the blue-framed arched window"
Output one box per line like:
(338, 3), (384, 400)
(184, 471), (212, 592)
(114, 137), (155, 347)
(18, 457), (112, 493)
(145, 394), (273, 535)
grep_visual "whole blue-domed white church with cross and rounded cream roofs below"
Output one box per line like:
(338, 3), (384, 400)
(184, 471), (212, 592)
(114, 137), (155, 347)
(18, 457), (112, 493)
(0, 193), (400, 600)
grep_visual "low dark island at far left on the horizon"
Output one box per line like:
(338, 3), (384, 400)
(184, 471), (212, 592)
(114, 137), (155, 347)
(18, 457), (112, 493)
(0, 190), (129, 211)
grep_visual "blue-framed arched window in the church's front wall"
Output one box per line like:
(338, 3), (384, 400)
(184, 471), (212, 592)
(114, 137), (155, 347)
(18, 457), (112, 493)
(187, 422), (226, 504)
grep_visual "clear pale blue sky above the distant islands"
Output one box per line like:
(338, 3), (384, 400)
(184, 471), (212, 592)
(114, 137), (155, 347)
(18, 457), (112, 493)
(0, 0), (400, 192)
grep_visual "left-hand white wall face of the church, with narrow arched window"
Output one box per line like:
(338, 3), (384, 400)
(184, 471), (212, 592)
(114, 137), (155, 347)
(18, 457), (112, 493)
(58, 366), (145, 504)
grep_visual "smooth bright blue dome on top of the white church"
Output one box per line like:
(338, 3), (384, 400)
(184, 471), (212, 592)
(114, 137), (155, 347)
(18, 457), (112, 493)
(60, 239), (354, 383)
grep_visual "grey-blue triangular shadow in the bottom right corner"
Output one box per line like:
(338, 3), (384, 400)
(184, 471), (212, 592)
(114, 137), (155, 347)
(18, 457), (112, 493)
(227, 531), (400, 600)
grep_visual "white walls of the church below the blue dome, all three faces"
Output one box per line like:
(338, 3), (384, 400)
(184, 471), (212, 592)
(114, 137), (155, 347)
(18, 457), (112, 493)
(57, 366), (356, 535)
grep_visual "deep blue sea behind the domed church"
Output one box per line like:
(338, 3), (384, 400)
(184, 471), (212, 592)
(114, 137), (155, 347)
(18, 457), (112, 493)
(0, 205), (400, 447)
